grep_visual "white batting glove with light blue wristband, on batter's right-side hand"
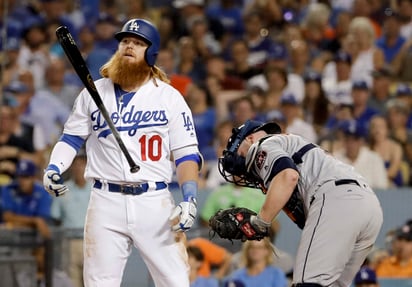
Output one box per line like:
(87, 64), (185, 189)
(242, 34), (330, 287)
(169, 181), (197, 232)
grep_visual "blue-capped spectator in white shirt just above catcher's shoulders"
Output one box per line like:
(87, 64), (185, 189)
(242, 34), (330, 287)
(280, 94), (318, 142)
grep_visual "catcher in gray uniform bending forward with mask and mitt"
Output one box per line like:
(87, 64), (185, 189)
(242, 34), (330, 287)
(210, 121), (383, 287)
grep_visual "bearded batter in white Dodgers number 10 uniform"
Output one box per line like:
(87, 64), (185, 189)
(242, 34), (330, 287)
(43, 19), (202, 287)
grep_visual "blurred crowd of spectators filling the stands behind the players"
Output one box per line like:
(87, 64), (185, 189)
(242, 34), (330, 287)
(0, 0), (412, 287)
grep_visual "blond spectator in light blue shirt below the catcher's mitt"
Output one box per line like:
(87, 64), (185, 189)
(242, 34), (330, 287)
(224, 239), (288, 287)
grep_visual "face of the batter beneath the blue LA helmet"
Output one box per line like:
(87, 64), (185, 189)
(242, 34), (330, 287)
(119, 36), (148, 63)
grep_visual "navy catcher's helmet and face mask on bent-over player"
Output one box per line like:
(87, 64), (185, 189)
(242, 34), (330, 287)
(219, 120), (281, 188)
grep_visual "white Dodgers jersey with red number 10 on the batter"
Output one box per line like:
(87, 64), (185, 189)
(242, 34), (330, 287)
(64, 78), (197, 182)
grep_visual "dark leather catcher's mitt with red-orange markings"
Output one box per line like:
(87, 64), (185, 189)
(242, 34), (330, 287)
(209, 207), (269, 241)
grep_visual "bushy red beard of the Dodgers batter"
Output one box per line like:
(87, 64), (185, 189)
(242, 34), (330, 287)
(107, 52), (150, 87)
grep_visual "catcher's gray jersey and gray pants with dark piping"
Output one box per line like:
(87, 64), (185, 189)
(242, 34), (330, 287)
(246, 134), (383, 286)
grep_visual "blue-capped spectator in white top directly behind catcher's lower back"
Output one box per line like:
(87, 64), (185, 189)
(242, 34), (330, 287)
(333, 121), (388, 189)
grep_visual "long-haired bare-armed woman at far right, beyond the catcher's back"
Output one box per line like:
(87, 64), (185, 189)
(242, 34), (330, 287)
(369, 115), (405, 187)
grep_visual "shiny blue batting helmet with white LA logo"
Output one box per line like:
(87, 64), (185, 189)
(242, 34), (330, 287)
(114, 19), (160, 67)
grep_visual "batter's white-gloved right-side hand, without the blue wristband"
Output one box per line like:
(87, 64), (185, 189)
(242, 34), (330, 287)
(169, 198), (197, 232)
